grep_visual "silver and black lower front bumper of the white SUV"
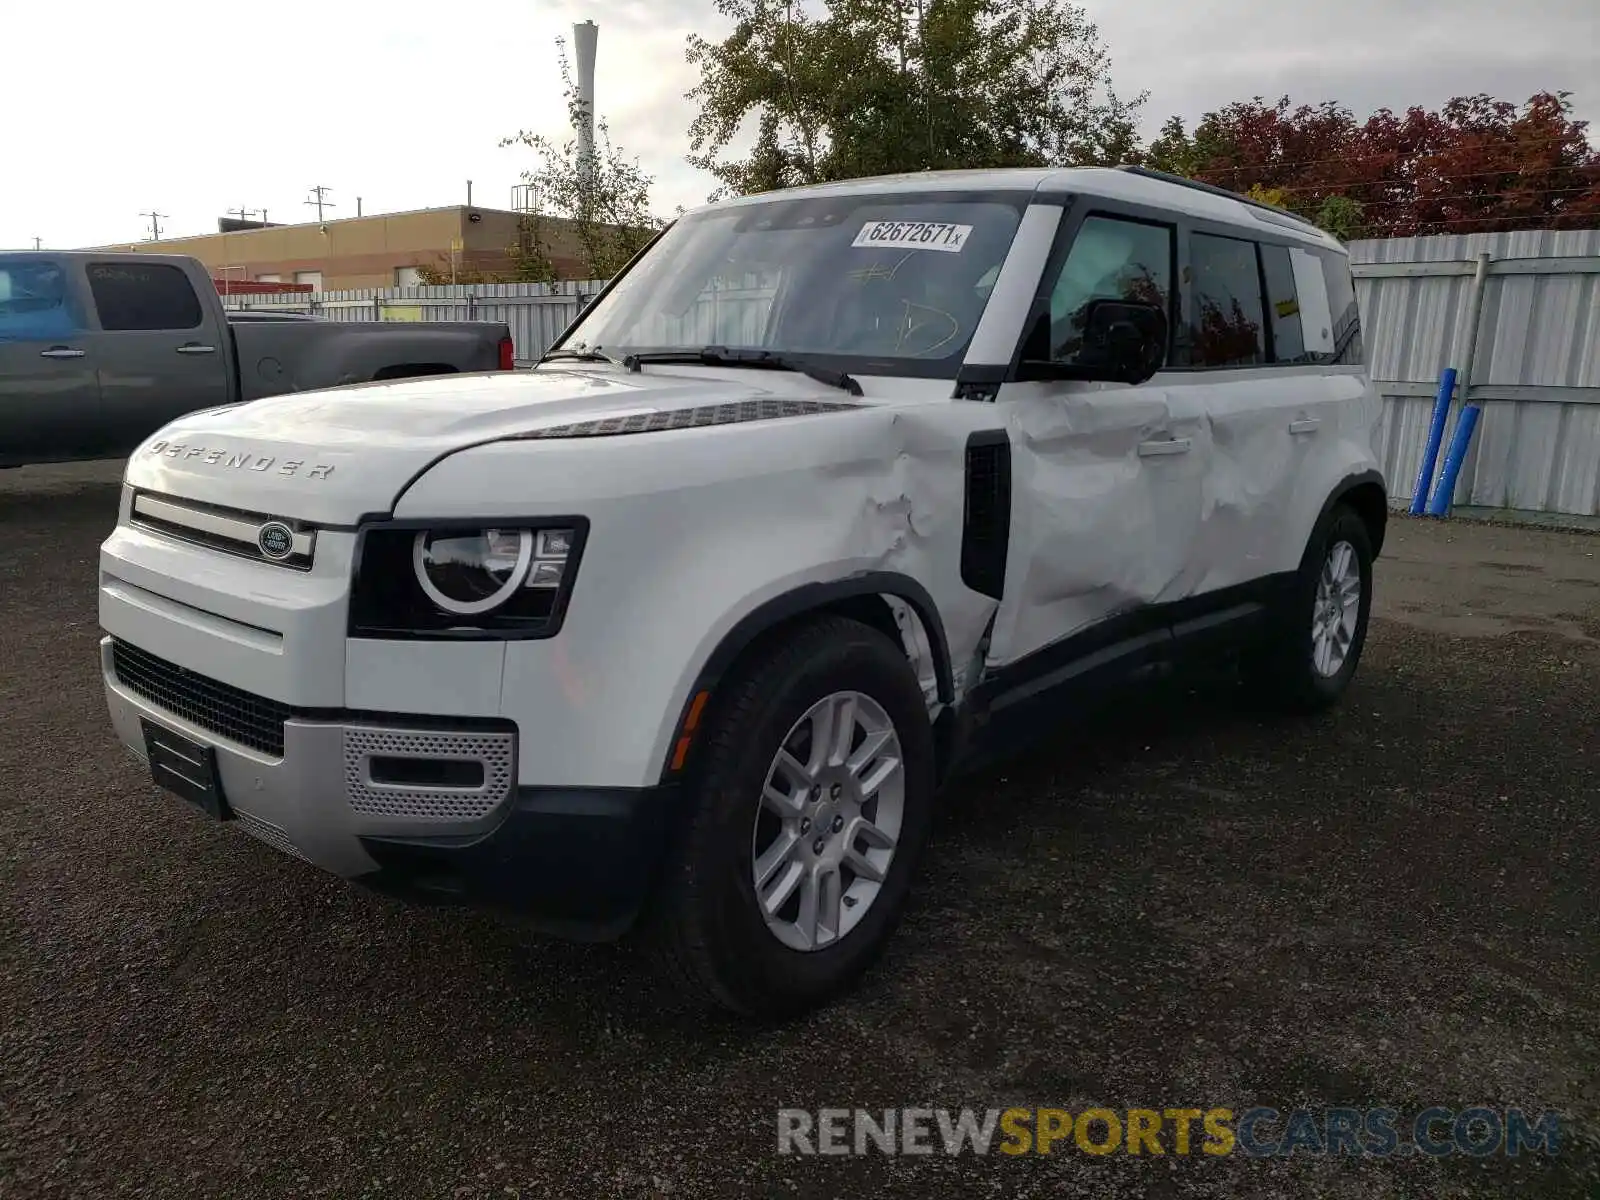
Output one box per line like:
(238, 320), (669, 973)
(101, 637), (677, 938)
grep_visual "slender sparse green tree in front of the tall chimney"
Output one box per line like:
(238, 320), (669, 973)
(501, 38), (664, 282)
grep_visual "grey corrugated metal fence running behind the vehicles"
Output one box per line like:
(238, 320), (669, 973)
(227, 230), (1600, 515)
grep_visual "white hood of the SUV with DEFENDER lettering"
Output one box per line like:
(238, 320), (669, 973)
(126, 368), (876, 525)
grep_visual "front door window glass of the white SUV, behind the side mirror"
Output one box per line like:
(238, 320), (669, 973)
(1050, 216), (1174, 363)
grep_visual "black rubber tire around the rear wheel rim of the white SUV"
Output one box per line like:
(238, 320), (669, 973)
(1243, 504), (1373, 714)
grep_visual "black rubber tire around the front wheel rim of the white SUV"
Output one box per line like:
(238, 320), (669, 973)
(645, 618), (934, 1019)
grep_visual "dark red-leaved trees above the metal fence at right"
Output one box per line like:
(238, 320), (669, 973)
(1146, 91), (1600, 238)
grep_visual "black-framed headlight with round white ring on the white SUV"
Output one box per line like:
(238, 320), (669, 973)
(350, 517), (587, 638)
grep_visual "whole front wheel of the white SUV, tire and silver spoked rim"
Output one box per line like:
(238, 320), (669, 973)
(653, 618), (934, 1019)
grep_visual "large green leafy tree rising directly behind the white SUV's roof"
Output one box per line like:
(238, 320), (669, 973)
(686, 0), (1144, 198)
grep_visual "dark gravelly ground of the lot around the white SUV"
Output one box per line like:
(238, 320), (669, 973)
(0, 464), (1600, 1200)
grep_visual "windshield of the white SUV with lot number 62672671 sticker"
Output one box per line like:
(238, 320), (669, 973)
(560, 194), (1026, 378)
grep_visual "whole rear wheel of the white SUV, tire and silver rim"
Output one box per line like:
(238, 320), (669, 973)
(1245, 504), (1373, 712)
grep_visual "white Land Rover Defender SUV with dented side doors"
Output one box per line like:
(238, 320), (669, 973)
(99, 170), (1387, 1014)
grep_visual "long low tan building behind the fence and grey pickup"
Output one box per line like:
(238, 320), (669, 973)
(87, 205), (582, 291)
